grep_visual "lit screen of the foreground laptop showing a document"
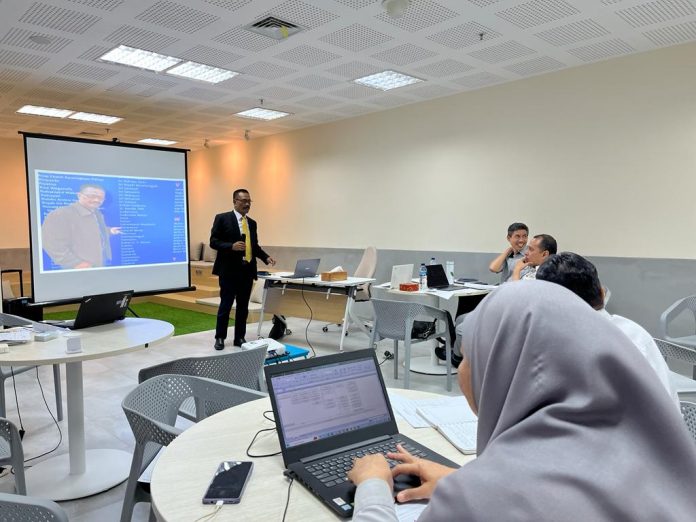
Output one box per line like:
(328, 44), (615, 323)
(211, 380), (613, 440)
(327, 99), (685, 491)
(272, 358), (391, 448)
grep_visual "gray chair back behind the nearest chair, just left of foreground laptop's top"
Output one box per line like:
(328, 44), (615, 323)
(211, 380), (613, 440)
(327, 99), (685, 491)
(138, 348), (266, 420)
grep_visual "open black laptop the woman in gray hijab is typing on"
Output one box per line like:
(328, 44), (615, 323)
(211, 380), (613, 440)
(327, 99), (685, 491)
(264, 349), (459, 517)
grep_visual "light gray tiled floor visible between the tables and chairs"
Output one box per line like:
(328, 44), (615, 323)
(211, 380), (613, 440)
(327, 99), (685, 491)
(0, 319), (460, 522)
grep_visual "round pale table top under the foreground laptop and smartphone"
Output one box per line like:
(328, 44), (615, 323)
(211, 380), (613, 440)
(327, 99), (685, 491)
(150, 389), (473, 522)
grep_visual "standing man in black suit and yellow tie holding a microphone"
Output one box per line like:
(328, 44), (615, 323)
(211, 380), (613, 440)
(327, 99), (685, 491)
(210, 189), (275, 350)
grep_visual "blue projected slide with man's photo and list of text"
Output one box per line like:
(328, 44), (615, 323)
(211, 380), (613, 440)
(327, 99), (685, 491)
(34, 170), (188, 272)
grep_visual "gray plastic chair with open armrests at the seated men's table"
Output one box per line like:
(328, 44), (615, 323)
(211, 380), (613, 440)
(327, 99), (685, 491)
(370, 299), (452, 391)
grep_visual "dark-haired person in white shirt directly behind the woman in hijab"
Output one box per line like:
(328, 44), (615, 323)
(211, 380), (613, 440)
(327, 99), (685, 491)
(536, 252), (679, 409)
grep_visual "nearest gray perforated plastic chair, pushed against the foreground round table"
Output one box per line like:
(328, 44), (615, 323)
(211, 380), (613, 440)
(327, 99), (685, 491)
(121, 374), (266, 522)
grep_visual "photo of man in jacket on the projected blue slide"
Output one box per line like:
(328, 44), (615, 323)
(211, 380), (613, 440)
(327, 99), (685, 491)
(41, 183), (121, 269)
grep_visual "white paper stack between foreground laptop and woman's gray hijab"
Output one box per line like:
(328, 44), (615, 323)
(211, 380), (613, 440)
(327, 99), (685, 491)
(416, 397), (478, 454)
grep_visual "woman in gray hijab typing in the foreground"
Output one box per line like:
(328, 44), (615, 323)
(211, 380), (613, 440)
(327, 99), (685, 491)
(349, 281), (696, 522)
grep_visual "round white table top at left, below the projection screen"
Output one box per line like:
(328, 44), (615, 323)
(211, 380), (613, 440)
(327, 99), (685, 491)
(0, 317), (174, 366)
